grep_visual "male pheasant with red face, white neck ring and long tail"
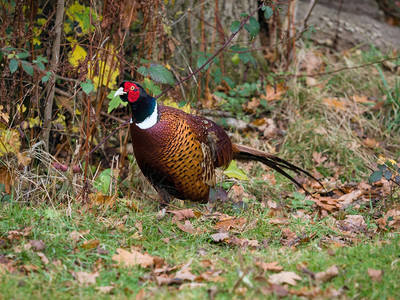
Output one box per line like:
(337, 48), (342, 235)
(114, 81), (319, 204)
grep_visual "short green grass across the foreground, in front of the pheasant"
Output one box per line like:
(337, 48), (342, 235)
(0, 198), (400, 299)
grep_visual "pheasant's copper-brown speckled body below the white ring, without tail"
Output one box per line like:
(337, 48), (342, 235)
(131, 106), (233, 202)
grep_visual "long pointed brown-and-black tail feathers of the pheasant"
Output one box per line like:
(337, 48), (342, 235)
(233, 144), (324, 195)
